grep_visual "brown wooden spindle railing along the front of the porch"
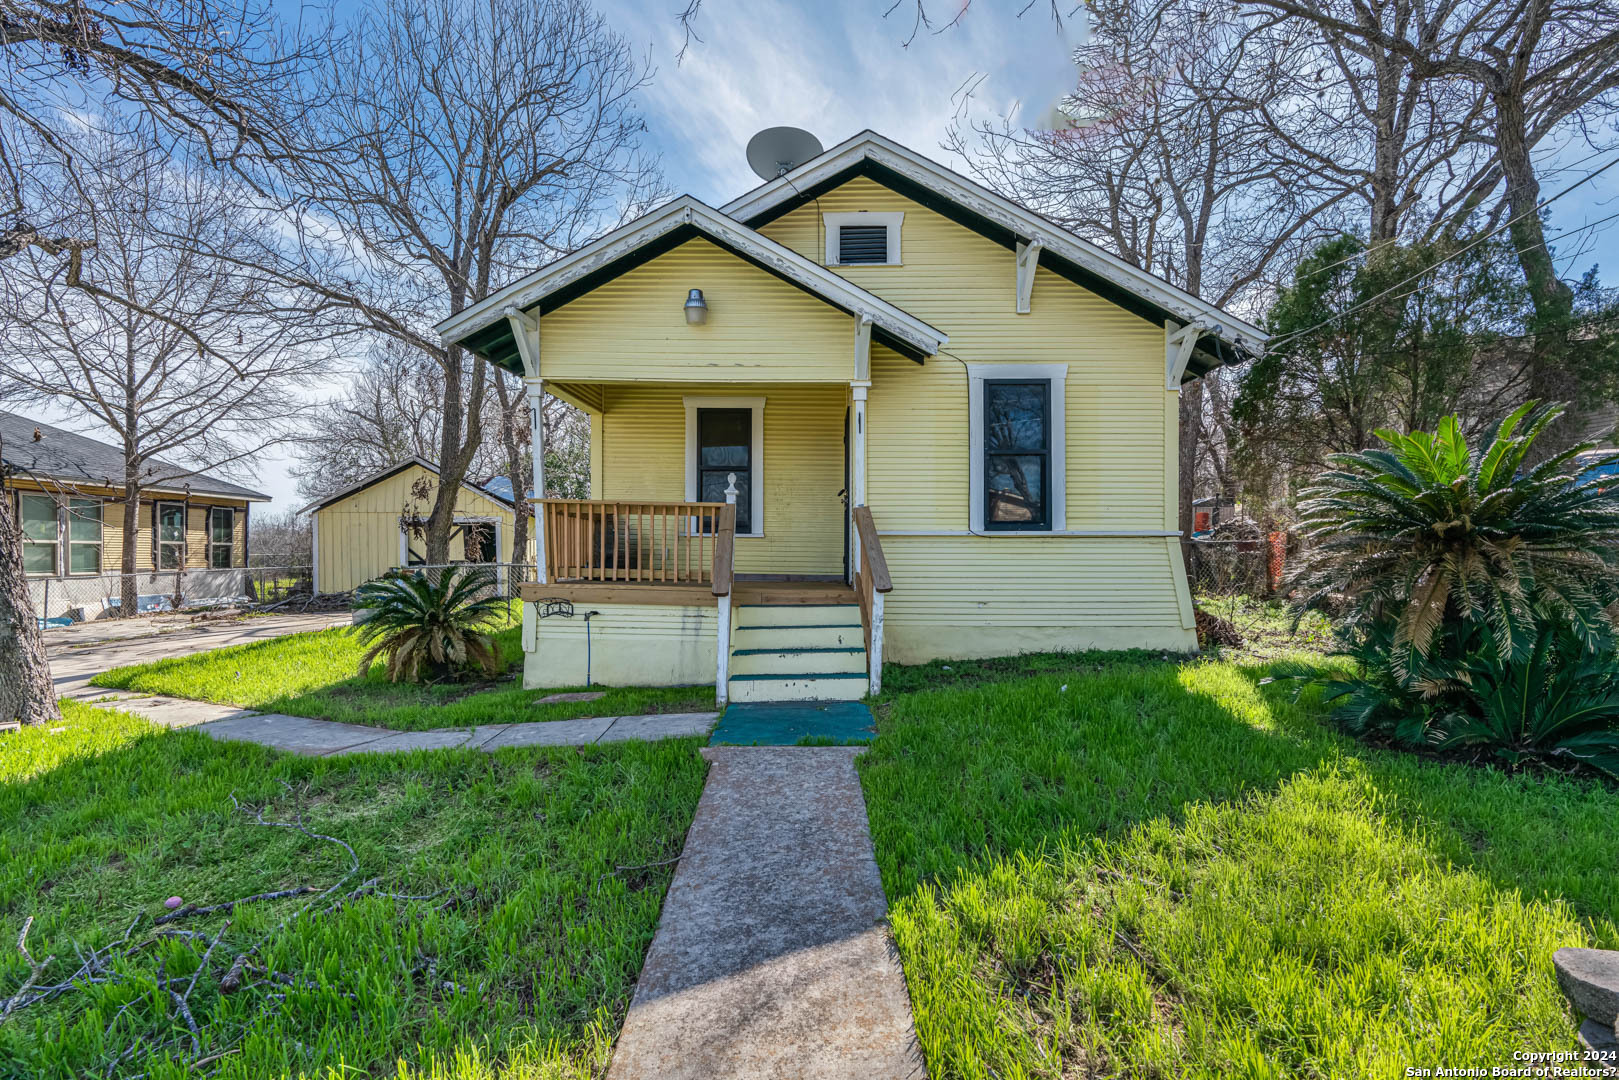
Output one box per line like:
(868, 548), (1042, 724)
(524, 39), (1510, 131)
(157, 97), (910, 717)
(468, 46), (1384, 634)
(538, 499), (737, 591)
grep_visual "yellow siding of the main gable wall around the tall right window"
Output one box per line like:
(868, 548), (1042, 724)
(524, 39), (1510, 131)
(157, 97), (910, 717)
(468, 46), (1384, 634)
(763, 178), (1177, 531)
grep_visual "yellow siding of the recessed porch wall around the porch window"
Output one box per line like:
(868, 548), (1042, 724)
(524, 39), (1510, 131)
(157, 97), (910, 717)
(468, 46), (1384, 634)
(599, 384), (845, 573)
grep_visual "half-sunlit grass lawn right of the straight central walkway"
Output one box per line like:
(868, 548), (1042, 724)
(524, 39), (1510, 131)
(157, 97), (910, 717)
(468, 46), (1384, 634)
(860, 654), (1619, 1080)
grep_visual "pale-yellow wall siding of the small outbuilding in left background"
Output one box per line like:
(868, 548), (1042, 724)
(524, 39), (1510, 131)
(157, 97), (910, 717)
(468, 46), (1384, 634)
(314, 466), (534, 593)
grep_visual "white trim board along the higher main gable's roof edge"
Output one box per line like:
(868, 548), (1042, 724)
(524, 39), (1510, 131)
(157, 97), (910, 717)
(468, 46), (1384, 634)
(720, 131), (1269, 350)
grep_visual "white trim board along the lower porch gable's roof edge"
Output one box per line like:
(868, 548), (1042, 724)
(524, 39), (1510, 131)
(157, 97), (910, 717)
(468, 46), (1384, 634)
(434, 194), (950, 356)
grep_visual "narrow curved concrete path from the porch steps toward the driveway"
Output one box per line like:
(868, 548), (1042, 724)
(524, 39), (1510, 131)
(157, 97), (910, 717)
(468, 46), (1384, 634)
(74, 687), (719, 758)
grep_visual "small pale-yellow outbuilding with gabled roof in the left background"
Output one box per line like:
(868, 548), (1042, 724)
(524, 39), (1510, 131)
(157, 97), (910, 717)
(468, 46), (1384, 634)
(303, 458), (534, 593)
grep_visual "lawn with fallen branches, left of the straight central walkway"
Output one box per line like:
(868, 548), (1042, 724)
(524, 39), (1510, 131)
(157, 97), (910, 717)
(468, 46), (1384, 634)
(0, 701), (704, 1080)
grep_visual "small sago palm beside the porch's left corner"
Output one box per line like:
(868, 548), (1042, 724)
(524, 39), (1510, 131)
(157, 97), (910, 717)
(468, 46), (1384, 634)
(355, 568), (505, 682)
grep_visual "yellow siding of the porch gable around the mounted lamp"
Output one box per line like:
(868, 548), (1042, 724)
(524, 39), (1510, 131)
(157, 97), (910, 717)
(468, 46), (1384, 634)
(539, 240), (855, 382)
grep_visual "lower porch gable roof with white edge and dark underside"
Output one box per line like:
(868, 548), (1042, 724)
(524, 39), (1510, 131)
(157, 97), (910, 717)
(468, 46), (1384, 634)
(437, 194), (950, 374)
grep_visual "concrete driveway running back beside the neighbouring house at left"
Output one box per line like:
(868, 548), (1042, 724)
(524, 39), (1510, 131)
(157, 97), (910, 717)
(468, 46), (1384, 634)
(45, 612), (350, 698)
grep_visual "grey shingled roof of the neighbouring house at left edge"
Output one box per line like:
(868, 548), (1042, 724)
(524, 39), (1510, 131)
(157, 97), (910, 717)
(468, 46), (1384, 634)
(0, 413), (270, 502)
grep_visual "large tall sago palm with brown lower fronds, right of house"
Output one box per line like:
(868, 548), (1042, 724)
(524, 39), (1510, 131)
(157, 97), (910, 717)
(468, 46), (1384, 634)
(1290, 402), (1619, 672)
